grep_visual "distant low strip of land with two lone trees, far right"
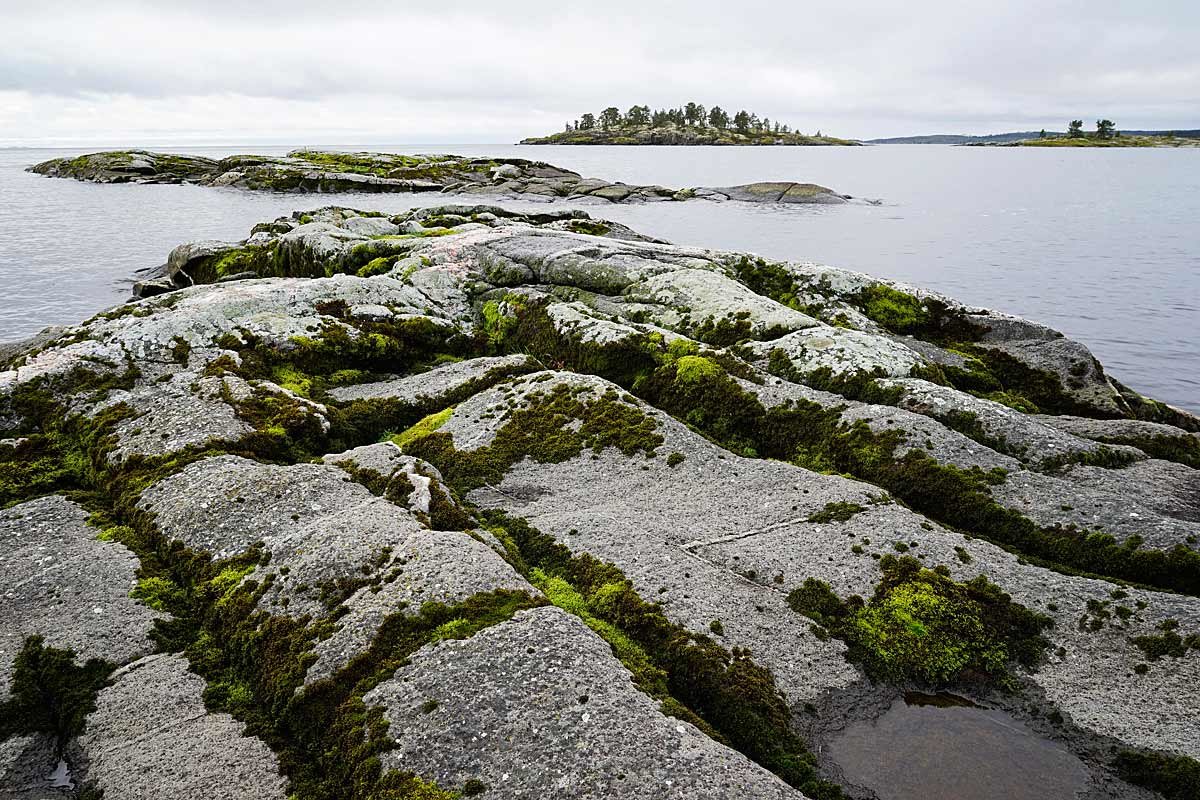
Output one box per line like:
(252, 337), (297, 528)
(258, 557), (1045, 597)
(864, 120), (1200, 148)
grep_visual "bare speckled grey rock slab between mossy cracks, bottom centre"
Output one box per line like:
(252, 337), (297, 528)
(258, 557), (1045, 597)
(364, 607), (804, 800)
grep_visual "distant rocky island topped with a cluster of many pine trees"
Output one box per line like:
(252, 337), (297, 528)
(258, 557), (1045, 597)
(518, 103), (862, 146)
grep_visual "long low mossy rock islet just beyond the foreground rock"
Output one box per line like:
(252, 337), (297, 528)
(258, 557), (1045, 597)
(30, 150), (850, 204)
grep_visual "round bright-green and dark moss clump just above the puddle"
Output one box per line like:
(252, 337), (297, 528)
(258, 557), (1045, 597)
(788, 555), (1050, 686)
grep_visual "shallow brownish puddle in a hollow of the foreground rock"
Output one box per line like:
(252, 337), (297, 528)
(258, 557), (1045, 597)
(829, 692), (1088, 800)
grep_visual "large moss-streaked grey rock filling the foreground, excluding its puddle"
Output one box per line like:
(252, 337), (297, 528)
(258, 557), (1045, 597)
(0, 199), (1200, 800)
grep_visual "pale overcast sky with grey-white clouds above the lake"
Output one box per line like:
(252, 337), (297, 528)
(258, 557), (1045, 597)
(0, 0), (1200, 145)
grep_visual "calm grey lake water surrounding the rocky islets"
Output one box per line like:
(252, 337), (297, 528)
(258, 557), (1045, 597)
(0, 145), (1200, 411)
